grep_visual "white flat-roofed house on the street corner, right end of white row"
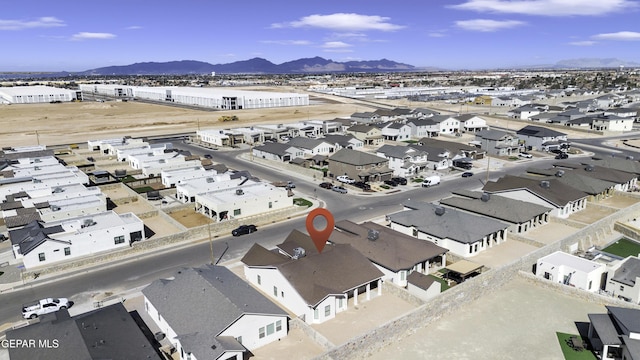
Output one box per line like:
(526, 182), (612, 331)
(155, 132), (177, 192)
(195, 182), (293, 221)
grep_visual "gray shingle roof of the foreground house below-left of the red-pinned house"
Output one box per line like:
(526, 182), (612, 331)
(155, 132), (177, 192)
(142, 265), (286, 359)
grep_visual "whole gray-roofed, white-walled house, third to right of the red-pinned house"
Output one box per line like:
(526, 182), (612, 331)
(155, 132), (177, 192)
(440, 190), (551, 234)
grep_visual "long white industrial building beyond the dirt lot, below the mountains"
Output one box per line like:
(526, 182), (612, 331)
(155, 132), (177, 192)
(80, 84), (309, 110)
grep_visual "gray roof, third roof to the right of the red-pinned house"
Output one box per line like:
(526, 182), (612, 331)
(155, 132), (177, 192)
(440, 191), (551, 224)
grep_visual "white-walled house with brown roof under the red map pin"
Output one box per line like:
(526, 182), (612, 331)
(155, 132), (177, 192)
(241, 230), (384, 324)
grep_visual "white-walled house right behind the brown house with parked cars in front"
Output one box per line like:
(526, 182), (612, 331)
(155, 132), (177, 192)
(376, 145), (428, 177)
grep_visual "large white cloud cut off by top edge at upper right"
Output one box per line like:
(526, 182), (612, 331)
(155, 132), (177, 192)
(450, 0), (637, 16)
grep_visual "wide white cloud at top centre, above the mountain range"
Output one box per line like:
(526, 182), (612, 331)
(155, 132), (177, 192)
(271, 13), (404, 31)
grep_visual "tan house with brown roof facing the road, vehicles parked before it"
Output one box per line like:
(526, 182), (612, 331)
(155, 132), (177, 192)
(328, 149), (393, 182)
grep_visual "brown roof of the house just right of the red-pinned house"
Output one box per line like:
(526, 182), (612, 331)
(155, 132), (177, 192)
(329, 220), (449, 272)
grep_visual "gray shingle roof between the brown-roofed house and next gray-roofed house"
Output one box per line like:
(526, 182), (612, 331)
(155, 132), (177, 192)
(388, 200), (508, 244)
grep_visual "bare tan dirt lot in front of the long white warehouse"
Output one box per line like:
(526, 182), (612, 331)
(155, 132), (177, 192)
(0, 90), (371, 146)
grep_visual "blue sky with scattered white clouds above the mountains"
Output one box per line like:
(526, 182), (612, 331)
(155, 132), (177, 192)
(0, 0), (640, 71)
